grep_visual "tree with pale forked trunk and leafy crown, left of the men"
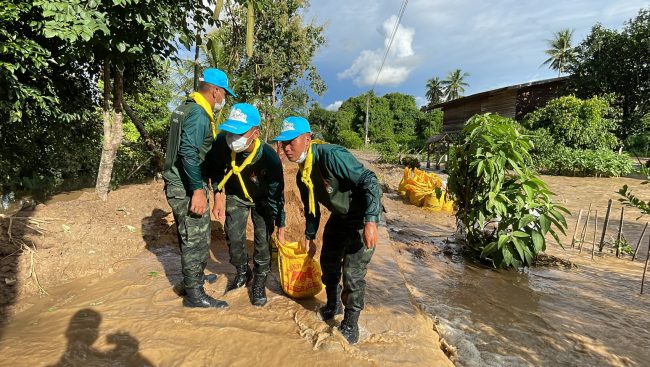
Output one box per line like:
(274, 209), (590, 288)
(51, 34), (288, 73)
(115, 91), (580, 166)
(35, 0), (213, 200)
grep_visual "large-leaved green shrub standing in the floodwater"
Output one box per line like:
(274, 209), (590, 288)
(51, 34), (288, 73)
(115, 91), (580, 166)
(448, 114), (568, 268)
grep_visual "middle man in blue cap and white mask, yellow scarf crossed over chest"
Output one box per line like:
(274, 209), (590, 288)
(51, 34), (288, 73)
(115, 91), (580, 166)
(207, 103), (285, 306)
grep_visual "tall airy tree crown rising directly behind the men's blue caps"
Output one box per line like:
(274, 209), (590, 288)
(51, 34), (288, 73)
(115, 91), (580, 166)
(200, 0), (326, 129)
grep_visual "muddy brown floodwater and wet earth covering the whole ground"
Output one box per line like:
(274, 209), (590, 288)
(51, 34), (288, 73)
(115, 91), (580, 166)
(0, 162), (650, 367)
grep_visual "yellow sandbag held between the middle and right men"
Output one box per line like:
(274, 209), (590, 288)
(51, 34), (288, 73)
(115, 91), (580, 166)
(272, 237), (323, 298)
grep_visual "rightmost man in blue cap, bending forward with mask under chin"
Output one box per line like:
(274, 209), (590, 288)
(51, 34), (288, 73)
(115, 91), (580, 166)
(274, 117), (382, 344)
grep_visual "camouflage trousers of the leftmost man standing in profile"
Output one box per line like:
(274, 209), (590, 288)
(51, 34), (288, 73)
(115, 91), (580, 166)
(165, 185), (211, 289)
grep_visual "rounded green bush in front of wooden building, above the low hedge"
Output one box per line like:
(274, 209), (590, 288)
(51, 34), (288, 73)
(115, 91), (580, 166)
(523, 96), (619, 149)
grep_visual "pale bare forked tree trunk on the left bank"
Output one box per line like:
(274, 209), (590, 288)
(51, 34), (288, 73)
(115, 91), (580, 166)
(95, 61), (124, 201)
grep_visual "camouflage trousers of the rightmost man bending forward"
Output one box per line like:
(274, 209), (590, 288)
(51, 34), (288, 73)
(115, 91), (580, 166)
(320, 214), (375, 311)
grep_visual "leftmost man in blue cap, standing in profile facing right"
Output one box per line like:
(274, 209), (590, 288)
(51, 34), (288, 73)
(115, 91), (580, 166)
(163, 69), (235, 308)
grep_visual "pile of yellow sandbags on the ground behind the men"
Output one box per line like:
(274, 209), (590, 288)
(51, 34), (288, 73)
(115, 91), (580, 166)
(398, 167), (454, 213)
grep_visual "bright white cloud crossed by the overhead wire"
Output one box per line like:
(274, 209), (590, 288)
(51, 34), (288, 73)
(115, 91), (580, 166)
(338, 15), (418, 87)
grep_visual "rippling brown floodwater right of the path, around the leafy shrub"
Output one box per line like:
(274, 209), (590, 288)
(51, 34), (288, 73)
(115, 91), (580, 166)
(386, 173), (650, 366)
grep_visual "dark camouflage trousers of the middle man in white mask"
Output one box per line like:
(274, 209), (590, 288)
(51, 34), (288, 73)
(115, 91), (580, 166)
(225, 195), (274, 275)
